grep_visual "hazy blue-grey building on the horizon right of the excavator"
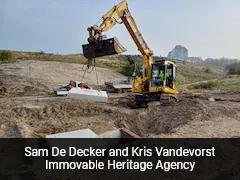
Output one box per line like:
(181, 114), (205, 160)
(168, 45), (188, 61)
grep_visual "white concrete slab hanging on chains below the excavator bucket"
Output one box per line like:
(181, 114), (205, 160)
(67, 88), (108, 102)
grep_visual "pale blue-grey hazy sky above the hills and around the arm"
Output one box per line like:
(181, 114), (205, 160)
(0, 0), (240, 59)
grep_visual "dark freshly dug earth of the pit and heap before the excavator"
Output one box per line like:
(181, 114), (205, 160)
(113, 99), (211, 137)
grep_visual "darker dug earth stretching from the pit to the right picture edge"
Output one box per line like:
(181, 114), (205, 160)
(113, 98), (240, 137)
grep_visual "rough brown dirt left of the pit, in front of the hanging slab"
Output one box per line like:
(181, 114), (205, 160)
(0, 99), (114, 137)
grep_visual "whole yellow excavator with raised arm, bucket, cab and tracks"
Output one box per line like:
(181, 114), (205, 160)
(82, 0), (177, 106)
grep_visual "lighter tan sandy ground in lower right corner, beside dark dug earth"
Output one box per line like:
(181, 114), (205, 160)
(155, 95), (240, 138)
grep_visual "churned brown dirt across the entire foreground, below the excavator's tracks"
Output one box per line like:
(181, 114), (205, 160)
(0, 93), (240, 137)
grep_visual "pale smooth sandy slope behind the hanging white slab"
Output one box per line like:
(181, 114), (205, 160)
(0, 60), (126, 87)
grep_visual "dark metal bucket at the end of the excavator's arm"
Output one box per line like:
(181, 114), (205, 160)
(82, 37), (126, 59)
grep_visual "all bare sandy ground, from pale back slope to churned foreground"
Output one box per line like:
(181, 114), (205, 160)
(0, 61), (240, 137)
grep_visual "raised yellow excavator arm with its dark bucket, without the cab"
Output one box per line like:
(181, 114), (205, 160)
(83, 0), (153, 79)
